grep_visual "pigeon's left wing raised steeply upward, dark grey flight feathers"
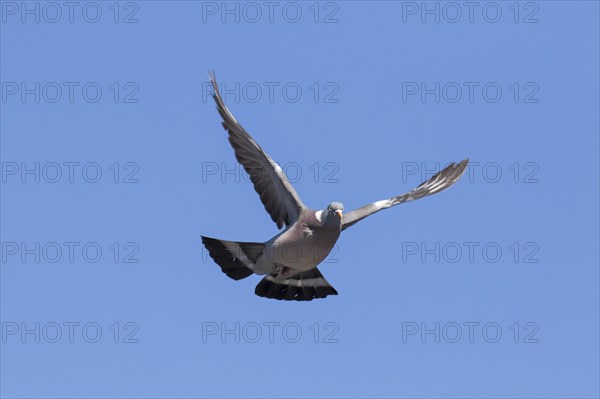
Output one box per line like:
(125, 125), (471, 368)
(210, 72), (305, 228)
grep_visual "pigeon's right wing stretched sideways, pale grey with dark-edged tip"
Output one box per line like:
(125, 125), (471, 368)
(342, 159), (469, 230)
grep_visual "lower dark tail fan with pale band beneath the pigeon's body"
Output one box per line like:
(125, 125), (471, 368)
(254, 268), (338, 301)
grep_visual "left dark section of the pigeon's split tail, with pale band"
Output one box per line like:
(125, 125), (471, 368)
(202, 236), (265, 280)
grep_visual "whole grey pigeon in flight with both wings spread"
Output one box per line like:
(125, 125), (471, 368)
(202, 72), (468, 301)
